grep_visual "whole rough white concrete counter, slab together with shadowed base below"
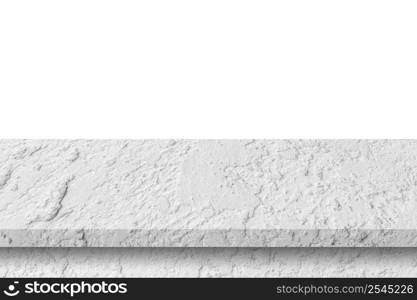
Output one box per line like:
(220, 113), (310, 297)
(0, 140), (417, 277)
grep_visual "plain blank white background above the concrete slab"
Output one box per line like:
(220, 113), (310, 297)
(0, 0), (417, 138)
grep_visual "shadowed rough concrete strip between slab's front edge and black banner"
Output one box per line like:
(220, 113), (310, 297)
(0, 248), (417, 277)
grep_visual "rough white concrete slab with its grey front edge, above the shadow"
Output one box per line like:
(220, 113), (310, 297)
(0, 140), (417, 247)
